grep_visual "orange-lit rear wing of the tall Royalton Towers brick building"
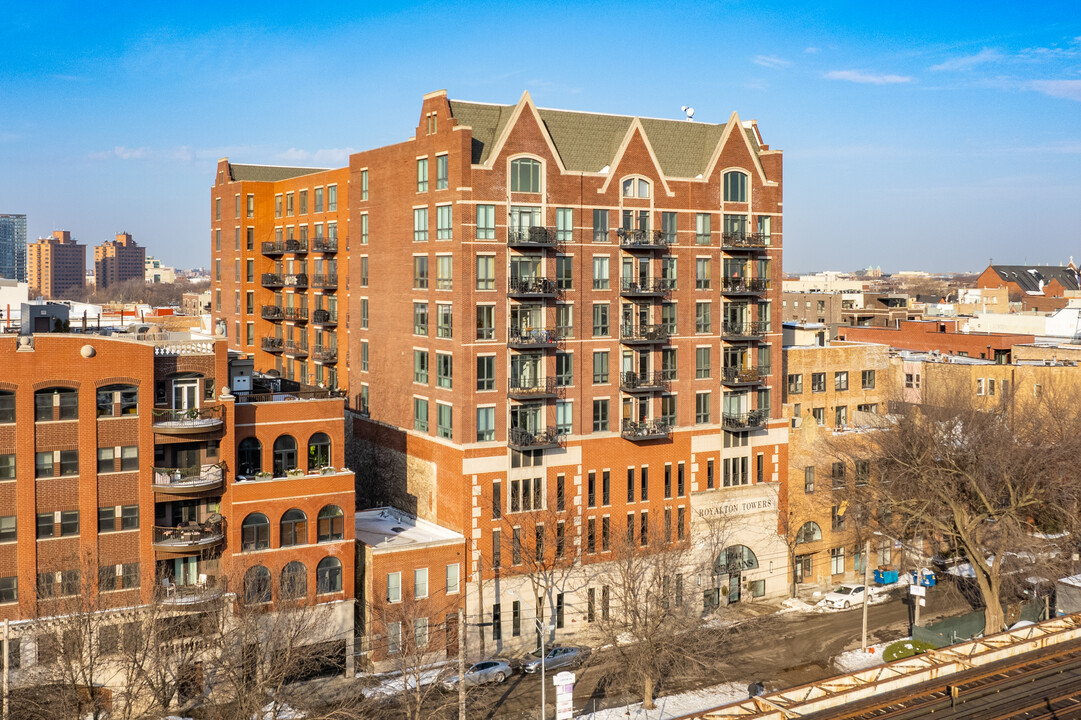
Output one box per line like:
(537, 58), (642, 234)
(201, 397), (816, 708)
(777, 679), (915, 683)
(211, 160), (348, 388)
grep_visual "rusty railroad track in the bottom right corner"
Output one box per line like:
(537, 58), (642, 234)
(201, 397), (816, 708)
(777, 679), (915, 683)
(803, 642), (1081, 720)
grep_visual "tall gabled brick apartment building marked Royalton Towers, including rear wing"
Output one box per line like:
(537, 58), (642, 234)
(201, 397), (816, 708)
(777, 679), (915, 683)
(211, 91), (788, 649)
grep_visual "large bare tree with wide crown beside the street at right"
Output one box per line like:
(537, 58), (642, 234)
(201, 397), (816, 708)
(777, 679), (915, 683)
(848, 366), (1081, 632)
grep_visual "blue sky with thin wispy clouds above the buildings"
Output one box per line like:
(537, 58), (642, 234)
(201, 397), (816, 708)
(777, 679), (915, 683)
(0, 1), (1081, 271)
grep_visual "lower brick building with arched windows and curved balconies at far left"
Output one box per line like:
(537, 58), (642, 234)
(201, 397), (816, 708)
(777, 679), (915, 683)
(0, 305), (356, 668)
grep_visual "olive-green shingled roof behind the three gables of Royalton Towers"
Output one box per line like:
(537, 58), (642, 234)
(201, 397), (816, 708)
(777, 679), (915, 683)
(449, 101), (758, 177)
